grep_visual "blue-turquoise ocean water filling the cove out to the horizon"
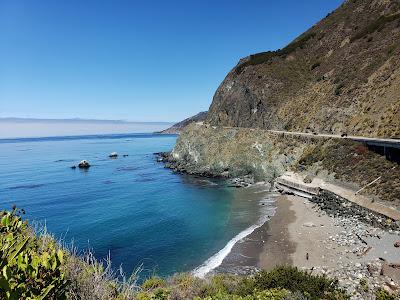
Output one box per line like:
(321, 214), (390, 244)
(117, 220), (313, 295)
(0, 134), (257, 276)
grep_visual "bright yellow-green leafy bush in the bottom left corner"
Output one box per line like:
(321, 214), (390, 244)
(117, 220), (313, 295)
(0, 207), (67, 300)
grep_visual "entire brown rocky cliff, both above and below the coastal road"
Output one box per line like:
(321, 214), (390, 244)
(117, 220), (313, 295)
(167, 0), (400, 207)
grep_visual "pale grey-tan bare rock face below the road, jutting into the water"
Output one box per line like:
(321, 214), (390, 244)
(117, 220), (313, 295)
(170, 124), (314, 181)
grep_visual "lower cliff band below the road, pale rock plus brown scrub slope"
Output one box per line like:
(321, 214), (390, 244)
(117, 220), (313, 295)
(169, 123), (400, 207)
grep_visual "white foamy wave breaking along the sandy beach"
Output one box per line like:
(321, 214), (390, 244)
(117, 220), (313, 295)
(192, 193), (275, 278)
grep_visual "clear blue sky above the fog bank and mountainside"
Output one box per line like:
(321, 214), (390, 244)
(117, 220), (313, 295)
(0, 0), (342, 121)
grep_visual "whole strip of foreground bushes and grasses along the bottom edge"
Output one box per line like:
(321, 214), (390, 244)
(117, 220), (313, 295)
(0, 208), (348, 300)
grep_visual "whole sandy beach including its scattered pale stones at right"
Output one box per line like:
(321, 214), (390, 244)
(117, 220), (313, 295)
(256, 196), (400, 299)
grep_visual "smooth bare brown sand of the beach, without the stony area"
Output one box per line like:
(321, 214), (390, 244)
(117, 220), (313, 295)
(259, 196), (350, 270)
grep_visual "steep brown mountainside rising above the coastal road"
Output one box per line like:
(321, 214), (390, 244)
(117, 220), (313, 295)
(207, 0), (400, 137)
